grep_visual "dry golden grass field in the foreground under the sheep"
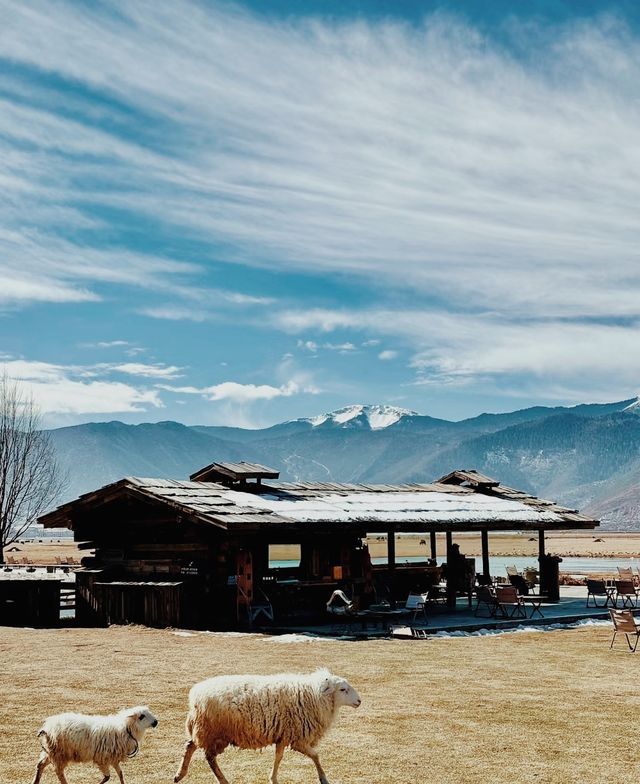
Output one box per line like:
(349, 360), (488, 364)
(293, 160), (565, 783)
(0, 627), (640, 784)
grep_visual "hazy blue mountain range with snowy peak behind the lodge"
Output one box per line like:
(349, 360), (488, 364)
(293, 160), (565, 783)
(50, 398), (640, 530)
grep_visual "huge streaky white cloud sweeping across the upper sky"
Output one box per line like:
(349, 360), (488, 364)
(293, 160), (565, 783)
(0, 0), (640, 318)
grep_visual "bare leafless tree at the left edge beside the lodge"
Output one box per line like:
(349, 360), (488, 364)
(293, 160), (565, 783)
(0, 372), (66, 563)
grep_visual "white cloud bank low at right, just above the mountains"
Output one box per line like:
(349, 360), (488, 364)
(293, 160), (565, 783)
(273, 309), (640, 400)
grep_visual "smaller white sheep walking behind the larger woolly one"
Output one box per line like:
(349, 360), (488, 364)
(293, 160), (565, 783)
(33, 705), (158, 784)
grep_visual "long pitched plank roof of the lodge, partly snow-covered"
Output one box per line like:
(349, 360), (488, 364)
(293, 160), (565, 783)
(40, 472), (598, 532)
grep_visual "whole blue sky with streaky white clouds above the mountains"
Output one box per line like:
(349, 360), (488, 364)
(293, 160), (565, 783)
(0, 0), (640, 427)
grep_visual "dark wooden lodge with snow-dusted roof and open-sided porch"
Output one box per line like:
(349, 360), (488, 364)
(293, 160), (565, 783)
(40, 463), (598, 629)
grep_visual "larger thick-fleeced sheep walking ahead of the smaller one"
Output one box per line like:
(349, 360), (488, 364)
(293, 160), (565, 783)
(174, 670), (360, 784)
